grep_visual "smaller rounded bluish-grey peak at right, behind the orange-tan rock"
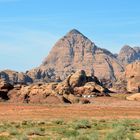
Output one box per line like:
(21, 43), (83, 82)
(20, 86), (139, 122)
(118, 45), (140, 66)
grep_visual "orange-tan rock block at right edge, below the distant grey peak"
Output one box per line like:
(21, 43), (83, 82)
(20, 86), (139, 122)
(125, 61), (140, 92)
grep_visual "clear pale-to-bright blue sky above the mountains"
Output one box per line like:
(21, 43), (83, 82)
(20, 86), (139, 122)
(0, 0), (140, 71)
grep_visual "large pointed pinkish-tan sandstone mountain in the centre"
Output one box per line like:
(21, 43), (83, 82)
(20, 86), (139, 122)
(28, 29), (124, 81)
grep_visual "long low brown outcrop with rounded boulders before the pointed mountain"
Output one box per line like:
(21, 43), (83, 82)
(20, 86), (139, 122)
(8, 70), (109, 103)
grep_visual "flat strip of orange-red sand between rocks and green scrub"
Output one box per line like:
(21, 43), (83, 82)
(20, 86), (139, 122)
(0, 97), (140, 121)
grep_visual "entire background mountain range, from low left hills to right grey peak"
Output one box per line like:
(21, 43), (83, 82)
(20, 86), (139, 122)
(0, 29), (140, 89)
